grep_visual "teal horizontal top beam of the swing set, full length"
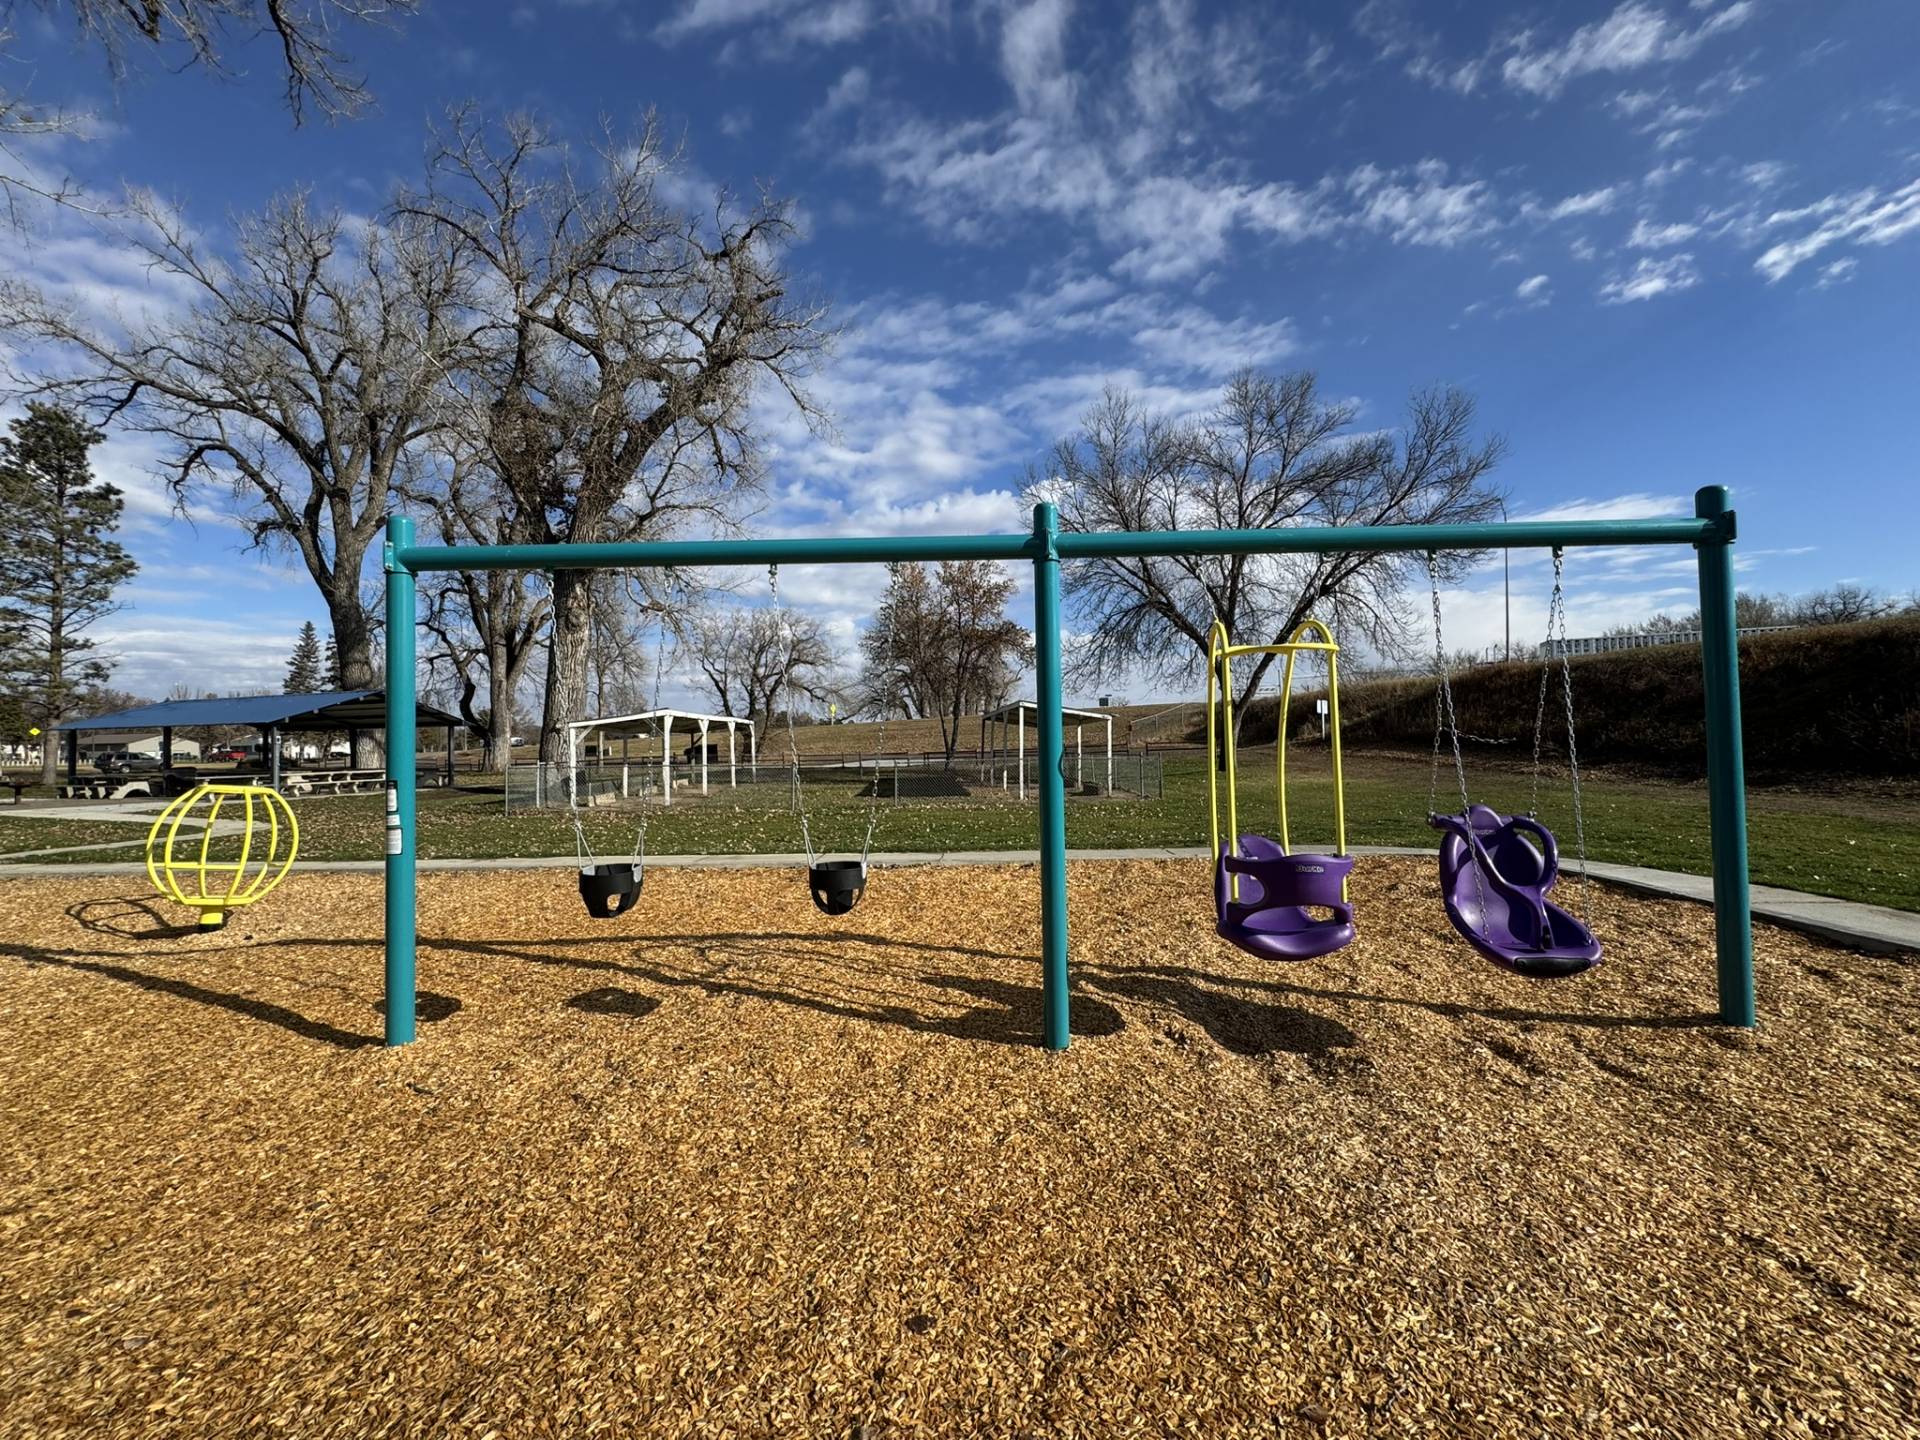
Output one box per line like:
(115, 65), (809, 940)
(390, 516), (1732, 572)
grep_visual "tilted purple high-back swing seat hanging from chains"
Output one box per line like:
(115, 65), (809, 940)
(1427, 804), (1599, 979)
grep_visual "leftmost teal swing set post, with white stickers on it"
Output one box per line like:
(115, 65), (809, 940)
(386, 515), (419, 1044)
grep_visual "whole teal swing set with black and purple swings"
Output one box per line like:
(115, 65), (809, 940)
(384, 486), (1755, 1050)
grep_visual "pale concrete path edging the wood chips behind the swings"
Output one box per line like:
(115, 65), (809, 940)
(0, 845), (1920, 952)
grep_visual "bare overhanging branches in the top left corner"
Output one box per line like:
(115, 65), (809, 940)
(0, 0), (419, 225)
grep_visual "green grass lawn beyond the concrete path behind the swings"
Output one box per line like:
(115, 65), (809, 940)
(0, 751), (1920, 910)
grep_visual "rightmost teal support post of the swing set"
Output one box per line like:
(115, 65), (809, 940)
(1693, 486), (1757, 1027)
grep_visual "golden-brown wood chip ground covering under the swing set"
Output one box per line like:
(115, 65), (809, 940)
(0, 860), (1920, 1440)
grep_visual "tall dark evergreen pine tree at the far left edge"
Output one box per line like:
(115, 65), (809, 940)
(0, 405), (138, 783)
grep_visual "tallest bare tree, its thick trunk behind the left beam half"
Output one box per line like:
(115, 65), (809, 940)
(401, 111), (824, 758)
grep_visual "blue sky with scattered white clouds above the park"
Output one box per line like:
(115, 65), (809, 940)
(0, 0), (1920, 706)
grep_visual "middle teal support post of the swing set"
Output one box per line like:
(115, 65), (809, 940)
(1033, 505), (1071, 1050)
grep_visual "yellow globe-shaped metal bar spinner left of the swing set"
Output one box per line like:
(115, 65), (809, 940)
(146, 785), (300, 929)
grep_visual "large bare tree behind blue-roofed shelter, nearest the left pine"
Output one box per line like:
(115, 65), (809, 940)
(0, 196), (470, 760)
